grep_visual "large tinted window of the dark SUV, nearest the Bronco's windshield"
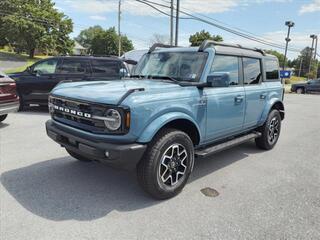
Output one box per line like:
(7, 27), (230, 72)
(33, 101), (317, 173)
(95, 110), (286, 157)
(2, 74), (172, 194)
(91, 60), (120, 76)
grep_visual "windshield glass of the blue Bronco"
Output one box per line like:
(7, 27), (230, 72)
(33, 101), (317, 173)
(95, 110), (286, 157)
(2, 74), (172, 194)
(134, 52), (208, 82)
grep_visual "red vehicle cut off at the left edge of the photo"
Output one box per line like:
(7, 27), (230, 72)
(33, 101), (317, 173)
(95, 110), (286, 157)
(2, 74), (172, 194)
(0, 69), (19, 122)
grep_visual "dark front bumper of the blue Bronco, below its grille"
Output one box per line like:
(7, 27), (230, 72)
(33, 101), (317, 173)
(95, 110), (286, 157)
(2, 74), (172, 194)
(46, 120), (147, 169)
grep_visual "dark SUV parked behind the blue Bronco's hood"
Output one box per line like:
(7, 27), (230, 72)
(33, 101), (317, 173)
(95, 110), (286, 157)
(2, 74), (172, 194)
(10, 56), (128, 110)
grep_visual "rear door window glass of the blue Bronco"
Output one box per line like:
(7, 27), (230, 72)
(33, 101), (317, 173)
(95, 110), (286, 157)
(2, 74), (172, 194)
(243, 58), (262, 84)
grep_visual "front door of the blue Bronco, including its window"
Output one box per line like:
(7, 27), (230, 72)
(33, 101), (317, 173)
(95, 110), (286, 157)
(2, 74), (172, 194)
(204, 55), (245, 141)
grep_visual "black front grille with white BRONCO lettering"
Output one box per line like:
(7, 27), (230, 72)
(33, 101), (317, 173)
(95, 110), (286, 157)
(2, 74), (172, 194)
(49, 97), (107, 133)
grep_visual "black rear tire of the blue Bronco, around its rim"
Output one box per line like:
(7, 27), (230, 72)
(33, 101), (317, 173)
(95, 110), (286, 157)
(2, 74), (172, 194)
(255, 109), (281, 150)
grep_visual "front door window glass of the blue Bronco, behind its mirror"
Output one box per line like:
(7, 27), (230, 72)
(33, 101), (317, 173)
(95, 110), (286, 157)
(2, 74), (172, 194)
(211, 55), (239, 85)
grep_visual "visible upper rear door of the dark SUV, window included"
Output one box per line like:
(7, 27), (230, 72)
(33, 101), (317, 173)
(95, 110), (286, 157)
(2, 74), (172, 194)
(91, 59), (125, 80)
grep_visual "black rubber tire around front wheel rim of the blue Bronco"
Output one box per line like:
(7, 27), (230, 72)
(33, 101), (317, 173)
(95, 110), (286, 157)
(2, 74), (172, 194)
(137, 129), (194, 199)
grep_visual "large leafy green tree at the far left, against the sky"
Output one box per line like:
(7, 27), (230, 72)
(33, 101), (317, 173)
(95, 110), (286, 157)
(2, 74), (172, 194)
(0, 0), (74, 58)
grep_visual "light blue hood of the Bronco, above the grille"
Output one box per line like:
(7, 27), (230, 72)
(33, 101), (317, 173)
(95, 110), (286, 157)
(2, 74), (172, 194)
(51, 79), (181, 105)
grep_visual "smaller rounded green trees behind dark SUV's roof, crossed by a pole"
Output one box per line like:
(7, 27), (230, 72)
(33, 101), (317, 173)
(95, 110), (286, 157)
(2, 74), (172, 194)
(76, 26), (133, 55)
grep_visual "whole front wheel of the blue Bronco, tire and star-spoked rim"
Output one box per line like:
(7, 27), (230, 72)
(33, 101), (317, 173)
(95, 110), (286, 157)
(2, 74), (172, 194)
(137, 129), (194, 199)
